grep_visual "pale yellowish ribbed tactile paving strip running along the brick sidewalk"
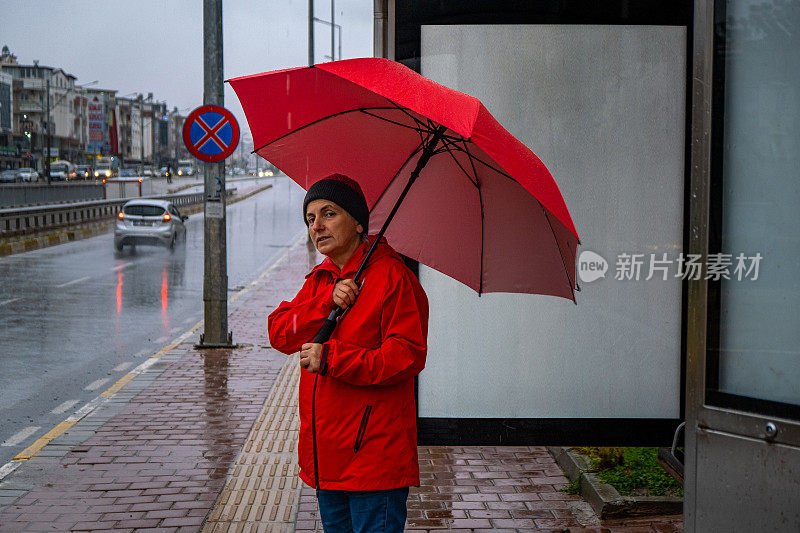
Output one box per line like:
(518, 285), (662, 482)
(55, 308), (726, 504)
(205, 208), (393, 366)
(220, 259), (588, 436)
(203, 357), (302, 533)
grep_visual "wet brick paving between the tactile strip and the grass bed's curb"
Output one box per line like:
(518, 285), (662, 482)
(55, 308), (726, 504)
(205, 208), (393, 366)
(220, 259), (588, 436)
(296, 446), (683, 533)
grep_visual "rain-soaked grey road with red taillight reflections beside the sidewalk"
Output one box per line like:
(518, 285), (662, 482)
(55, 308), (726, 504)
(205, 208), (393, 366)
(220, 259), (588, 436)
(0, 177), (305, 466)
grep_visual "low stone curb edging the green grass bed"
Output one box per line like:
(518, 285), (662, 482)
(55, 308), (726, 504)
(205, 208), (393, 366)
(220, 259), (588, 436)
(547, 446), (683, 519)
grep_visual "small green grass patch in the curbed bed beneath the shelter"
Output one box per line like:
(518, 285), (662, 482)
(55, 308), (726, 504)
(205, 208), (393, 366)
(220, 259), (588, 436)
(575, 447), (683, 497)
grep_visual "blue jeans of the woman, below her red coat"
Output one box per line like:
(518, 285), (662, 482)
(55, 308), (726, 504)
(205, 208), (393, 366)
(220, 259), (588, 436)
(317, 487), (408, 533)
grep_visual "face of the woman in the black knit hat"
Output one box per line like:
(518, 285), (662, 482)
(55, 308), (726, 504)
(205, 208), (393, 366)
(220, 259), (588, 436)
(306, 199), (364, 268)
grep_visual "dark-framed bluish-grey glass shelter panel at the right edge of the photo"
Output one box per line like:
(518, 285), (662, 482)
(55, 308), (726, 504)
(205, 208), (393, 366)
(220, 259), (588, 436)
(705, 0), (800, 418)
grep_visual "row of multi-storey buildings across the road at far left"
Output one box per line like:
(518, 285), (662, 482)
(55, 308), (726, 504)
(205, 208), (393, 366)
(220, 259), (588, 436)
(0, 47), (188, 171)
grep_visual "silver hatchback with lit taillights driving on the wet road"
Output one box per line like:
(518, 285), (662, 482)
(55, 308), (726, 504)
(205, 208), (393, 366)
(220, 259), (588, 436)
(114, 199), (189, 252)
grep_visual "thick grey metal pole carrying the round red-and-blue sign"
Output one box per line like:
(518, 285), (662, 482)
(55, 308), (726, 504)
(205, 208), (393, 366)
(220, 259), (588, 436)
(198, 0), (233, 348)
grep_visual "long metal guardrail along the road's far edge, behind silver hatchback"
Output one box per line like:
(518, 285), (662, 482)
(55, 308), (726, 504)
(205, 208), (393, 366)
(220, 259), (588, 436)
(0, 189), (236, 237)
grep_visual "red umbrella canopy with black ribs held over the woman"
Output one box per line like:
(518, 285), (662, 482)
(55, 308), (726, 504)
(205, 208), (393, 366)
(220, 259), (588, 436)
(229, 58), (579, 301)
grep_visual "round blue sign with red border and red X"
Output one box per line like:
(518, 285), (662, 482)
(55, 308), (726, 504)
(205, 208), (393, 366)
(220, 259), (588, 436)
(183, 105), (239, 163)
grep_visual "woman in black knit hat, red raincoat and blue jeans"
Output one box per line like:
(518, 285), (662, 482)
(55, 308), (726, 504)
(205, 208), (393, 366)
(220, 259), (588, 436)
(268, 174), (428, 532)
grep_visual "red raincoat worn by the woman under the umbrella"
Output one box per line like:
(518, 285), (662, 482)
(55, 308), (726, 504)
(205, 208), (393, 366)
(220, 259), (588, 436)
(268, 237), (428, 490)
